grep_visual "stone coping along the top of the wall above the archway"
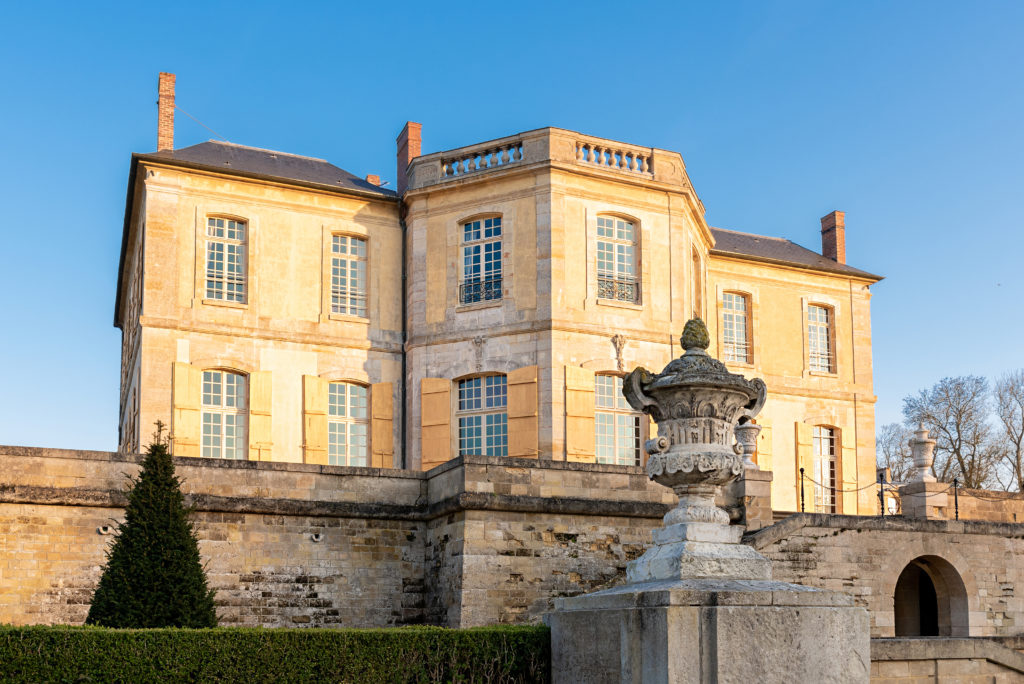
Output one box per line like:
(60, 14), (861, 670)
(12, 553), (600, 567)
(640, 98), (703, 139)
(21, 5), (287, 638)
(743, 513), (1024, 549)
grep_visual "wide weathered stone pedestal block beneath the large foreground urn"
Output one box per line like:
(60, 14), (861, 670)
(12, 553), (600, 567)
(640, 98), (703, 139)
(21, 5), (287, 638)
(545, 580), (870, 684)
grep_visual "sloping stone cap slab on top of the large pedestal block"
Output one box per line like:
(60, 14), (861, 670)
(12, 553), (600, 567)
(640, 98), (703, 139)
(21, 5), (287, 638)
(555, 580), (857, 610)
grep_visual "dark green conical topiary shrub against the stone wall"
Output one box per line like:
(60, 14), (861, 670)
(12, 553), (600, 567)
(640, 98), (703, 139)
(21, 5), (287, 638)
(85, 423), (217, 628)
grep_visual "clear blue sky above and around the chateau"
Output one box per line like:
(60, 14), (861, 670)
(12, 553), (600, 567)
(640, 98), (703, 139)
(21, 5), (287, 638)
(0, 0), (1024, 450)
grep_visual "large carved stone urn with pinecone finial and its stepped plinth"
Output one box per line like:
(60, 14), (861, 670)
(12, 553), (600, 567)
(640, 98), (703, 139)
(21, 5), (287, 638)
(623, 318), (770, 583)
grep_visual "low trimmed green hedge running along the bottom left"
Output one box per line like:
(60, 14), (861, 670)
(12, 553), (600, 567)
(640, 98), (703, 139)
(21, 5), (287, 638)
(0, 626), (551, 684)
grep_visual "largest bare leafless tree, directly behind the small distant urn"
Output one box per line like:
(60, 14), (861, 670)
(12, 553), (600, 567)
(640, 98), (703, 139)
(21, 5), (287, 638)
(903, 375), (1000, 488)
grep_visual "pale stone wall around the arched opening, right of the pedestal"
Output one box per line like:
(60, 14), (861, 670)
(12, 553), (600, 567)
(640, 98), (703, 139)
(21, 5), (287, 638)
(746, 513), (1024, 637)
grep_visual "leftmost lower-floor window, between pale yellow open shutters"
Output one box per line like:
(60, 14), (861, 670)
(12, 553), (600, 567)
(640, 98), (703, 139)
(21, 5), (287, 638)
(203, 371), (249, 461)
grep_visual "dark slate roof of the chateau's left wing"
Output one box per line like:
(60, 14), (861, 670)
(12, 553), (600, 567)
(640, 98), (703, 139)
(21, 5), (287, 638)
(135, 140), (397, 199)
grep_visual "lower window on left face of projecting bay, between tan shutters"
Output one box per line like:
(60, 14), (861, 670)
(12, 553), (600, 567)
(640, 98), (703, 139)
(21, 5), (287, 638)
(458, 375), (509, 456)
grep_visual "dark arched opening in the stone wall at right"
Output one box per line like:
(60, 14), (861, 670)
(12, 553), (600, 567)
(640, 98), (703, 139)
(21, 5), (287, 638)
(893, 555), (970, 637)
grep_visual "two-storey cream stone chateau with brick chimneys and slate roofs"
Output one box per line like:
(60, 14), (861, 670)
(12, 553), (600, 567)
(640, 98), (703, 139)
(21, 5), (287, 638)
(115, 74), (880, 514)
